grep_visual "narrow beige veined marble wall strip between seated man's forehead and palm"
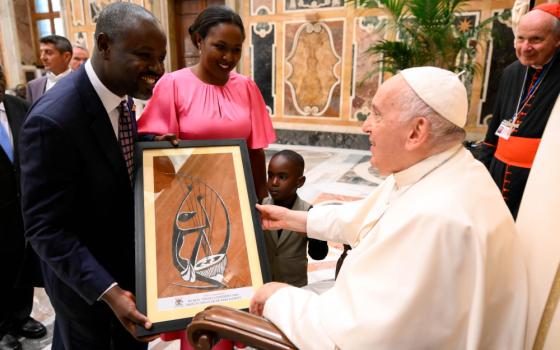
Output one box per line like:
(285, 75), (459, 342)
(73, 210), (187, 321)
(351, 16), (385, 121)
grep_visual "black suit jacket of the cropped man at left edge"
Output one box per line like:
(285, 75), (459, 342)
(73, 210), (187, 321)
(0, 95), (35, 286)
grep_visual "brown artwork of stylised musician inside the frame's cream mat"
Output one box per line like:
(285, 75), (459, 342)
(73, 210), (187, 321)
(154, 153), (251, 298)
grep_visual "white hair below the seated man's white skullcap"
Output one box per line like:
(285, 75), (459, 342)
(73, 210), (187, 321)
(396, 78), (466, 145)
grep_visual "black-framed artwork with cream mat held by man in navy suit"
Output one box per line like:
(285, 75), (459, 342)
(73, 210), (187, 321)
(135, 140), (270, 336)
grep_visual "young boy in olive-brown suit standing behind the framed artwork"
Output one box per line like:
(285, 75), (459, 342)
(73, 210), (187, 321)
(263, 150), (329, 287)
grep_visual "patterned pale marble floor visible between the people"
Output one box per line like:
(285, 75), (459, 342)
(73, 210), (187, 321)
(22, 144), (382, 350)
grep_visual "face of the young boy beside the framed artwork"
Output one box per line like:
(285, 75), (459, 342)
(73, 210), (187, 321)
(266, 156), (305, 201)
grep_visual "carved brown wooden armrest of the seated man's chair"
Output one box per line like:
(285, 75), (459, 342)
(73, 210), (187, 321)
(187, 305), (297, 350)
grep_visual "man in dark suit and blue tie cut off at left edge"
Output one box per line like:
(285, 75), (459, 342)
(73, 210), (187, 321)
(0, 65), (47, 350)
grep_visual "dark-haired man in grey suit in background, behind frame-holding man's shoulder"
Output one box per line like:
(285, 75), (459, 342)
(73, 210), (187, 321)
(26, 35), (72, 103)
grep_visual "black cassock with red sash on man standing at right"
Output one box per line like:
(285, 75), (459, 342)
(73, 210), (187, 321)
(479, 50), (560, 218)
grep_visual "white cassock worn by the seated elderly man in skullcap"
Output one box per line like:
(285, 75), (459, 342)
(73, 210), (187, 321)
(264, 146), (527, 350)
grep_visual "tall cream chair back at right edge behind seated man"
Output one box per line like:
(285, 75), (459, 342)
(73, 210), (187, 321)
(516, 98), (560, 350)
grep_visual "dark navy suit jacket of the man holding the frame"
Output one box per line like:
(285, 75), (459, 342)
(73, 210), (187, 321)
(20, 67), (134, 308)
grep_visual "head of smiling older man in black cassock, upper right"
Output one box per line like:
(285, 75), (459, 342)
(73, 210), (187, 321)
(515, 10), (560, 67)
